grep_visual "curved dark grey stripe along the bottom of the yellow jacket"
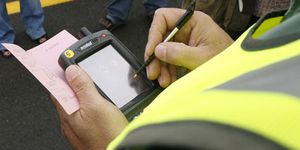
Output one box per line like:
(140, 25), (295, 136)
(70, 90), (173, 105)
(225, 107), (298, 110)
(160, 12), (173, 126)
(117, 121), (286, 150)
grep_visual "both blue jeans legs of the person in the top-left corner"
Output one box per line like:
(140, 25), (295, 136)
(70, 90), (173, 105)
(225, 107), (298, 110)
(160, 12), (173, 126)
(0, 0), (46, 51)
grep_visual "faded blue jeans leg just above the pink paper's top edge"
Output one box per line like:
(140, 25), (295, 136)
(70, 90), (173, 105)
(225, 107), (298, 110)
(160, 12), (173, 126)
(20, 0), (46, 40)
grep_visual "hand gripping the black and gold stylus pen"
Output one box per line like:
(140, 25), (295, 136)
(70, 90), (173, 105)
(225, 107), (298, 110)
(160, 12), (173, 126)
(144, 8), (233, 87)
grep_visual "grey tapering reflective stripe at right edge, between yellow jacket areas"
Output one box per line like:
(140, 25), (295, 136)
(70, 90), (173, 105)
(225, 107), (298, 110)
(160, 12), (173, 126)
(216, 56), (300, 97)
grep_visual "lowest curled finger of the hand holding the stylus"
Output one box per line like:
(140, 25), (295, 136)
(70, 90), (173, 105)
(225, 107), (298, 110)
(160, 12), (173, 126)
(158, 62), (171, 88)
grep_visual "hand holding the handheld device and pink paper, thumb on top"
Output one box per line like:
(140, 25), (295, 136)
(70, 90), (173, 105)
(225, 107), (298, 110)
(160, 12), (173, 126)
(51, 65), (128, 150)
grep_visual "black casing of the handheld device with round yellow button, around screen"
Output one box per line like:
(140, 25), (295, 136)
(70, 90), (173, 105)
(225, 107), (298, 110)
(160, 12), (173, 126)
(58, 30), (162, 120)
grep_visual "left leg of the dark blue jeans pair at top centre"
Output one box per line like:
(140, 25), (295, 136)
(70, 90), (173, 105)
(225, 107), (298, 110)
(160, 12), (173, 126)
(106, 0), (132, 24)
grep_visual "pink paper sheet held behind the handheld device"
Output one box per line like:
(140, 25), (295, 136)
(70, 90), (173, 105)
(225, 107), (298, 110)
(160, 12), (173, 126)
(3, 30), (79, 114)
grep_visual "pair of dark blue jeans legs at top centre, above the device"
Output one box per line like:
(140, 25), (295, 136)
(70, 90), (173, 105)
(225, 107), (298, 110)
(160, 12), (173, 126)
(106, 0), (168, 24)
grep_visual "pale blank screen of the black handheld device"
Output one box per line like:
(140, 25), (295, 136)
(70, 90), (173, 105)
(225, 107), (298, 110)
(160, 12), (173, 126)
(78, 45), (147, 108)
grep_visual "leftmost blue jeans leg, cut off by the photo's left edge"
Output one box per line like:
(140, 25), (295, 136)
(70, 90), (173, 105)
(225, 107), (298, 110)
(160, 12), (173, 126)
(0, 0), (15, 51)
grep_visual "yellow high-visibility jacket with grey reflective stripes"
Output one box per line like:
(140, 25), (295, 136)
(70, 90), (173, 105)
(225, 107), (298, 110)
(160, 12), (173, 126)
(108, 9), (300, 150)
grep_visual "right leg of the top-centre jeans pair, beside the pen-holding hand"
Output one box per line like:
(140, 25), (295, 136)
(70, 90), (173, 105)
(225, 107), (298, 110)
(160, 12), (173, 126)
(144, 0), (168, 16)
